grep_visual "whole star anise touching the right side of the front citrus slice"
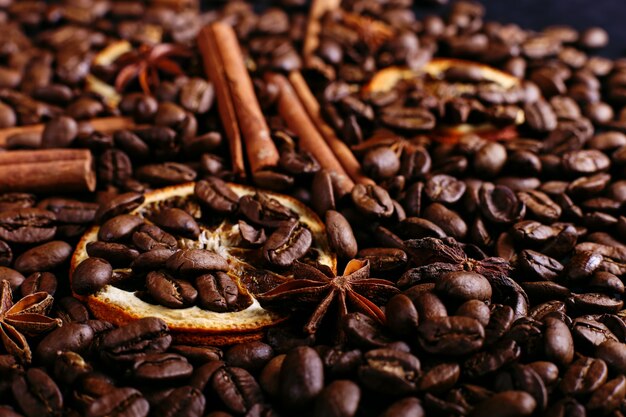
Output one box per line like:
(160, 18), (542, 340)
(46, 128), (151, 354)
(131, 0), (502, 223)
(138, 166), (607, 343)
(257, 259), (399, 334)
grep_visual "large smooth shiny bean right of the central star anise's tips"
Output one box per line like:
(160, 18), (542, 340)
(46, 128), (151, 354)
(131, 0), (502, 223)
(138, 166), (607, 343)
(435, 271), (491, 302)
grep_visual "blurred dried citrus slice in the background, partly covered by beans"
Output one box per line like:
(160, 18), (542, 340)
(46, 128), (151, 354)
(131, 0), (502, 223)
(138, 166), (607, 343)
(362, 58), (524, 142)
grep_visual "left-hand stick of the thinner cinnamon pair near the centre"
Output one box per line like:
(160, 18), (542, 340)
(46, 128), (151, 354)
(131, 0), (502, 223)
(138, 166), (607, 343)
(265, 73), (354, 194)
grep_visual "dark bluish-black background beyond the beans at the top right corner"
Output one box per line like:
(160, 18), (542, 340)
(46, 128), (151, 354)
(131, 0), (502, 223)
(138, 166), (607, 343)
(415, 0), (626, 58)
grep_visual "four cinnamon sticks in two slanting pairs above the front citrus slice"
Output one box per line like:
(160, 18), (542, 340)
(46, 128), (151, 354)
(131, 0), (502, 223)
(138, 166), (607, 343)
(198, 22), (373, 194)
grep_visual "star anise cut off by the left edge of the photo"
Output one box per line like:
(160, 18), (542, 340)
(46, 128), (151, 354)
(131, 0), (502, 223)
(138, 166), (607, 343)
(0, 280), (62, 363)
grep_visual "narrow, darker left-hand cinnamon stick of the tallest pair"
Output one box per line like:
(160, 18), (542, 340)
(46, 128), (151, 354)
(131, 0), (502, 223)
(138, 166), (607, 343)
(198, 26), (246, 178)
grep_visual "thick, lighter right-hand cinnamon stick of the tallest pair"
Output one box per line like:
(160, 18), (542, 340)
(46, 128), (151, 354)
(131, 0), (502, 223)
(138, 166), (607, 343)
(210, 22), (279, 177)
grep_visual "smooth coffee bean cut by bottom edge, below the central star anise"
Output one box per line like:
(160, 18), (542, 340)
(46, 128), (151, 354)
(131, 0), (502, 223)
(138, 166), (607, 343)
(313, 380), (361, 417)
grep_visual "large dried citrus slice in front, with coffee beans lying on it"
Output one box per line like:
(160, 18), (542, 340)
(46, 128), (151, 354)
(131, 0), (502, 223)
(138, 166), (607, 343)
(70, 183), (336, 345)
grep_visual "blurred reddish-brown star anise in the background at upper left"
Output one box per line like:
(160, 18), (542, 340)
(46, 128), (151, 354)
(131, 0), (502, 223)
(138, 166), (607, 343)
(115, 43), (191, 94)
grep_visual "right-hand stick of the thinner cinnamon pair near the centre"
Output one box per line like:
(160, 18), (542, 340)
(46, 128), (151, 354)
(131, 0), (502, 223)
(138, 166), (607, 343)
(289, 71), (374, 185)
